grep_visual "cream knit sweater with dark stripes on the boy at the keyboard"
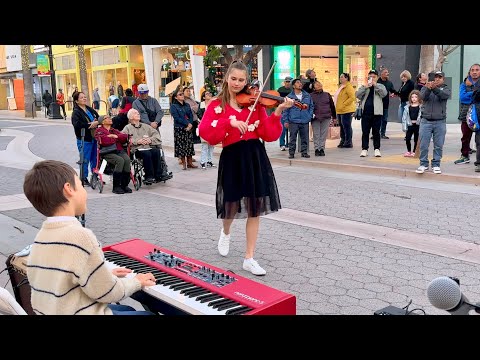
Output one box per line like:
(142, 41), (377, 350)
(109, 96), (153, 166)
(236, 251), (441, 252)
(27, 219), (141, 315)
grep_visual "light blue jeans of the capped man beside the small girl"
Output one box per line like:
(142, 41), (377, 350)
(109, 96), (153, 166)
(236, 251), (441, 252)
(420, 119), (447, 167)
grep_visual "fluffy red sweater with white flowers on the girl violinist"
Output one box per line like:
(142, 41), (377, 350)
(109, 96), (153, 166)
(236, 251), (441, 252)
(199, 99), (282, 147)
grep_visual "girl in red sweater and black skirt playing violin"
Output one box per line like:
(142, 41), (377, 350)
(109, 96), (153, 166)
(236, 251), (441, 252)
(199, 61), (294, 275)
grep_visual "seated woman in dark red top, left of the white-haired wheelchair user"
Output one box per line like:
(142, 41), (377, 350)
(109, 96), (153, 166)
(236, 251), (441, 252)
(95, 115), (132, 194)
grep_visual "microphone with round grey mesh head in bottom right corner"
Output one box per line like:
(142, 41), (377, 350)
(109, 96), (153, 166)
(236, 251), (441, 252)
(427, 276), (480, 315)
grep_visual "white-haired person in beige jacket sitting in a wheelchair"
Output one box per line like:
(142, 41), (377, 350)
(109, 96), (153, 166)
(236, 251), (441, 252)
(122, 108), (173, 184)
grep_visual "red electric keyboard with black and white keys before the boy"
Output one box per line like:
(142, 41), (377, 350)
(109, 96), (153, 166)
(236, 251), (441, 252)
(103, 239), (296, 315)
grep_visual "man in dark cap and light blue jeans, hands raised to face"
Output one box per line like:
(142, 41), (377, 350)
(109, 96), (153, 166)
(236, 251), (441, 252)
(416, 71), (452, 174)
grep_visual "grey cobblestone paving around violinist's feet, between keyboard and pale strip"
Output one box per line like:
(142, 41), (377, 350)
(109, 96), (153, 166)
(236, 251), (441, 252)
(3, 192), (480, 314)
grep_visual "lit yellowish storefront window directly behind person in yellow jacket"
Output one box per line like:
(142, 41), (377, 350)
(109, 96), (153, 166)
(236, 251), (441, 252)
(341, 45), (375, 89)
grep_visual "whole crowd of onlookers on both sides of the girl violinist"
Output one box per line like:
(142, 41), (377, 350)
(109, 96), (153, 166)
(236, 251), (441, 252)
(68, 64), (480, 193)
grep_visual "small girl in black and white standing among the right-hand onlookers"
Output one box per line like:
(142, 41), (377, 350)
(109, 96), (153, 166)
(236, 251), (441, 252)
(402, 90), (422, 157)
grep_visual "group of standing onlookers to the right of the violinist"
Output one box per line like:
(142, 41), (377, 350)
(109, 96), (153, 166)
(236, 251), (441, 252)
(277, 64), (480, 174)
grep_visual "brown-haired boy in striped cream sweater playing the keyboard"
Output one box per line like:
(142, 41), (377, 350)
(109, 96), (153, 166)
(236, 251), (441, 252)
(23, 160), (155, 315)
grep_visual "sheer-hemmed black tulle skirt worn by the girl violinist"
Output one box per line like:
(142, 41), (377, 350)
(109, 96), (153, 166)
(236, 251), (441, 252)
(216, 139), (281, 219)
